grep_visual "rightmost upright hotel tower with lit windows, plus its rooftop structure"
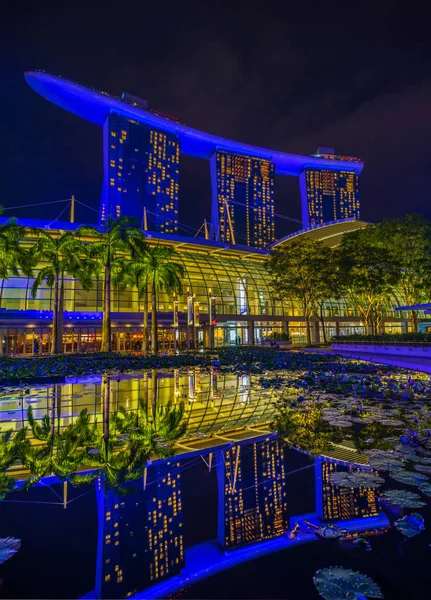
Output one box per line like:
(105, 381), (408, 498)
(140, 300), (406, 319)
(300, 148), (360, 227)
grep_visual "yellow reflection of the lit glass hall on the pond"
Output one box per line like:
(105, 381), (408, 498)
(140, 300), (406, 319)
(0, 368), (275, 435)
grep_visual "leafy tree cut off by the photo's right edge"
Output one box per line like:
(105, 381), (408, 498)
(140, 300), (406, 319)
(376, 215), (431, 332)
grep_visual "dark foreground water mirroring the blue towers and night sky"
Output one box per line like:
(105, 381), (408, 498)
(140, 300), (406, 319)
(0, 435), (431, 598)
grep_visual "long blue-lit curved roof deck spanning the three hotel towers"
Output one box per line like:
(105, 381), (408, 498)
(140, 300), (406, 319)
(25, 71), (363, 176)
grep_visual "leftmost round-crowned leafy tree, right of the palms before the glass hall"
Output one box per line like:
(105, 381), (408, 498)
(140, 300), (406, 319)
(266, 239), (336, 345)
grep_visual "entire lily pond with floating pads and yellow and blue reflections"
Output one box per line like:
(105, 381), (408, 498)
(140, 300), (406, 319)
(0, 362), (431, 599)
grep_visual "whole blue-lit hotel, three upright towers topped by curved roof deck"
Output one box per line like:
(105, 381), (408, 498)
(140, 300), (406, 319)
(25, 71), (363, 239)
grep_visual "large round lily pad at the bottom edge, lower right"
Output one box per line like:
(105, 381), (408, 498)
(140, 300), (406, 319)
(313, 567), (383, 600)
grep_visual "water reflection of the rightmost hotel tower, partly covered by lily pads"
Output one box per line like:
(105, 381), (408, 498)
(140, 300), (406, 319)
(315, 458), (379, 521)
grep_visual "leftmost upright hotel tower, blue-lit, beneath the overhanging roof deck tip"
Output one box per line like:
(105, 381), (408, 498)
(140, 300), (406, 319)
(99, 113), (180, 233)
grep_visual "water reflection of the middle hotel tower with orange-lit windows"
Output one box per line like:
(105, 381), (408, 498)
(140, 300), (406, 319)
(217, 439), (288, 549)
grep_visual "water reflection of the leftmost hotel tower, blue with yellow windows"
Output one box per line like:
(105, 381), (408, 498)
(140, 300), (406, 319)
(96, 463), (184, 598)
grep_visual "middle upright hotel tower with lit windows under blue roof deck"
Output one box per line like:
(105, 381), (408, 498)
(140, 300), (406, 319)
(211, 150), (275, 248)
